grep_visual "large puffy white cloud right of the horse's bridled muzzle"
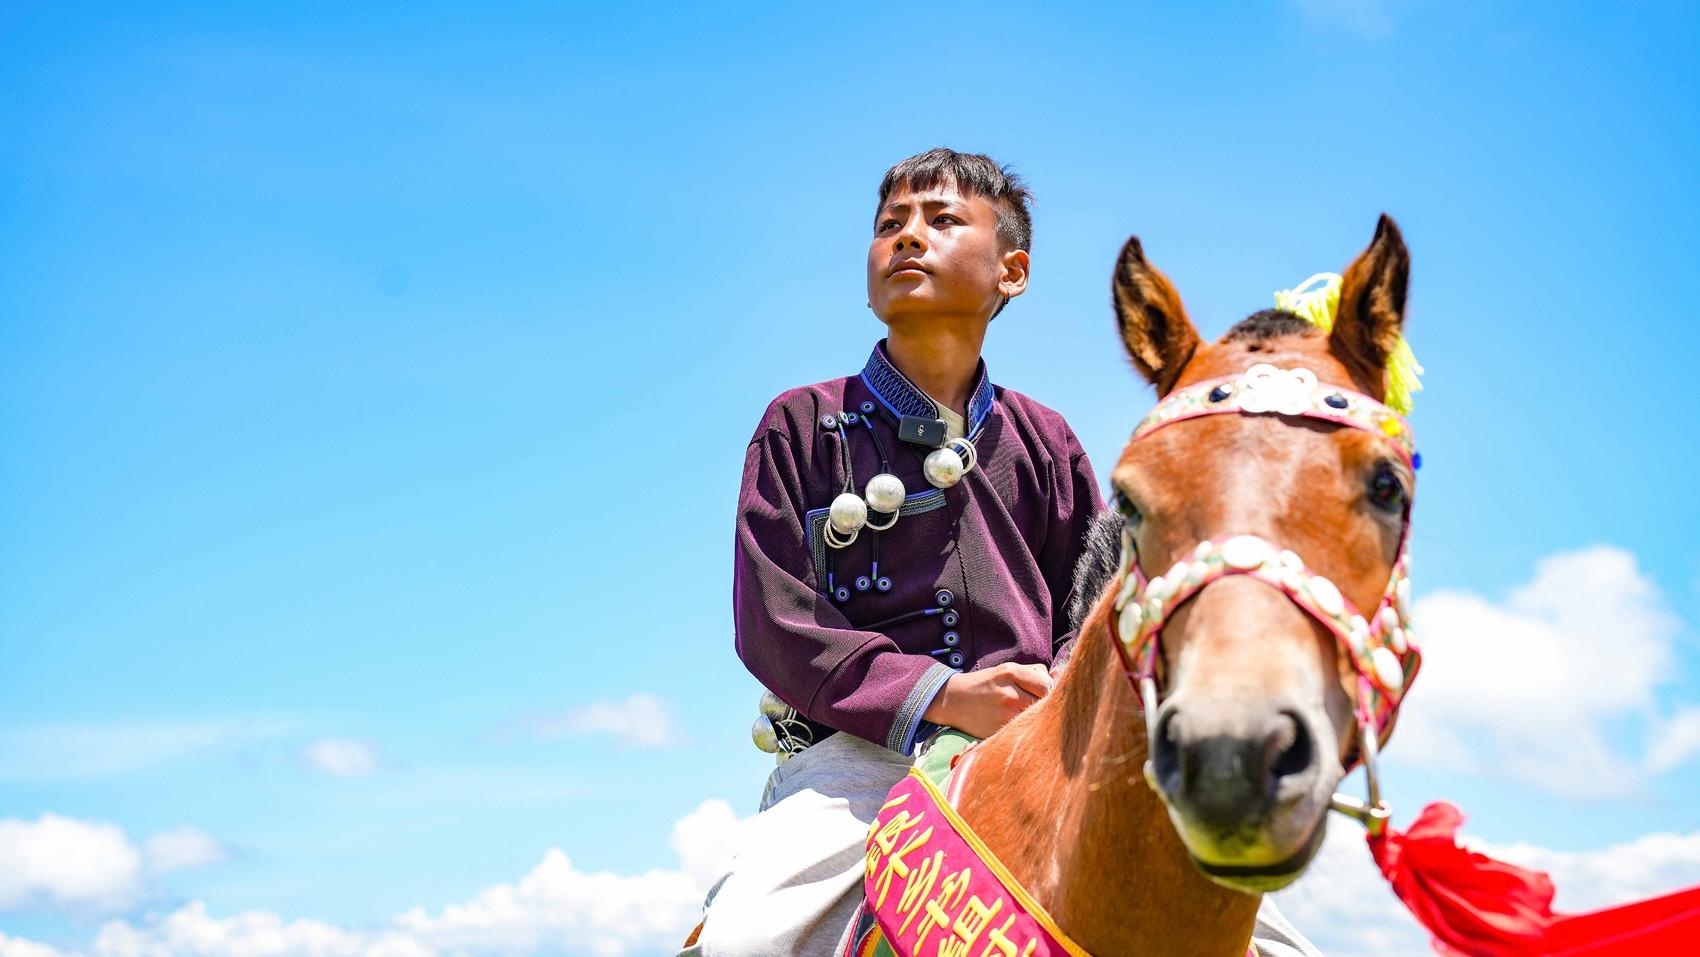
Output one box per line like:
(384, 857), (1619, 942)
(1392, 546), (1700, 797)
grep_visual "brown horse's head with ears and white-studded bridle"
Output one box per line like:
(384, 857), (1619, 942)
(1090, 216), (1418, 892)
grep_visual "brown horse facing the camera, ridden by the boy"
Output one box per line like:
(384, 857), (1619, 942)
(957, 216), (1413, 957)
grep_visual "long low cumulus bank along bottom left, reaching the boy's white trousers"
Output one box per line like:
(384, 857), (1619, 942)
(0, 801), (741, 957)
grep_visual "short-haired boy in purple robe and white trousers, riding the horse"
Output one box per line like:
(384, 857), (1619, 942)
(683, 150), (1319, 957)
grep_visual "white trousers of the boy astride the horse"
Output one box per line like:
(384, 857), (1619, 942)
(680, 731), (1321, 957)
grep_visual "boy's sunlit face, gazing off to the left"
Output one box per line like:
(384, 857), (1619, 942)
(867, 184), (1027, 325)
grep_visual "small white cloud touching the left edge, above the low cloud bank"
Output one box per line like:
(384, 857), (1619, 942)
(0, 814), (228, 917)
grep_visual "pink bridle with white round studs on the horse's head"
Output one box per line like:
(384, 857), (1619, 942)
(1110, 364), (1421, 833)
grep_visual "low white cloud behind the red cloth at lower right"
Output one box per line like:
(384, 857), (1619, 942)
(1275, 821), (1700, 957)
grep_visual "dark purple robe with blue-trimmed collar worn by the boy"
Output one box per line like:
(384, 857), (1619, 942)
(733, 342), (1102, 755)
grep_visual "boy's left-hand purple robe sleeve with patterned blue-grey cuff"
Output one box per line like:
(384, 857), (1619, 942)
(733, 428), (955, 755)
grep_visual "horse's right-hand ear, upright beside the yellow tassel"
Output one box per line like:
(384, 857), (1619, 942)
(1328, 212), (1411, 399)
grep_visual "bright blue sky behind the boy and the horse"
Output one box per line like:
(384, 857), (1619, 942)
(0, 0), (1700, 957)
